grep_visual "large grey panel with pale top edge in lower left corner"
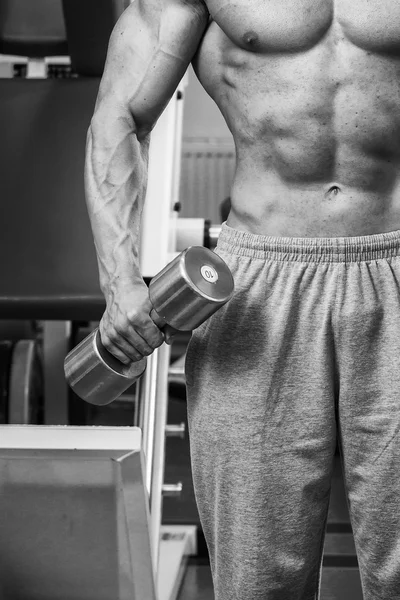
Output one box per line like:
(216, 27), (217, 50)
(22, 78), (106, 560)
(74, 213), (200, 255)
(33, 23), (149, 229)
(0, 425), (159, 600)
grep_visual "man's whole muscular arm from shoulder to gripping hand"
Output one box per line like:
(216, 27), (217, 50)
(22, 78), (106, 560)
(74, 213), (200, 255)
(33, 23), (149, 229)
(85, 0), (208, 363)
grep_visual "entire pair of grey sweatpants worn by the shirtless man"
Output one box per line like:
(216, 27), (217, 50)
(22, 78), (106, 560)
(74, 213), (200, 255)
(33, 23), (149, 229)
(186, 225), (400, 600)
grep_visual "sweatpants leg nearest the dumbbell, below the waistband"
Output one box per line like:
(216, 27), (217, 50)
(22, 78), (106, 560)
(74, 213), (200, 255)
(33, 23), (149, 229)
(186, 226), (338, 600)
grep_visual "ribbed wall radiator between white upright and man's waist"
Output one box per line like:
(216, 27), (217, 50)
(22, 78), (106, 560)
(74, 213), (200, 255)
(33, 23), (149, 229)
(179, 139), (235, 223)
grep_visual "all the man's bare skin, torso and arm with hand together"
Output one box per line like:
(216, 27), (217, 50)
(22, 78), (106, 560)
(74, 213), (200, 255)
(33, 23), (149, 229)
(86, 0), (400, 363)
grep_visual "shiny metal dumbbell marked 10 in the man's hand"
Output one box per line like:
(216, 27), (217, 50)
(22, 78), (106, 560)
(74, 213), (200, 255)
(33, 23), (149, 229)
(64, 246), (234, 405)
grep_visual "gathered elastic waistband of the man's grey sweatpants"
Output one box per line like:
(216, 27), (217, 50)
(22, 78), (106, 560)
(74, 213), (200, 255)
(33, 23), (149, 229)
(217, 223), (400, 263)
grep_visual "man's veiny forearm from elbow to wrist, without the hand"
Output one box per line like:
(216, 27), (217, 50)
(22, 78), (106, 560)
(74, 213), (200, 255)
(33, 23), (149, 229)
(85, 104), (149, 296)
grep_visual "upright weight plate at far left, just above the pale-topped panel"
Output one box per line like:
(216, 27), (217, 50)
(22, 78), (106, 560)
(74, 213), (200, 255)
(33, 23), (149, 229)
(8, 340), (43, 425)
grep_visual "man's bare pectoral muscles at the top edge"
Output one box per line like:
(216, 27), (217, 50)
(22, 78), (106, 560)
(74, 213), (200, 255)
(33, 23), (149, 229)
(206, 0), (400, 55)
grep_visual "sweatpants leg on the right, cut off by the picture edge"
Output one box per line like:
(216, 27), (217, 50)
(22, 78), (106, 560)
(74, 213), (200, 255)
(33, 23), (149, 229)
(335, 256), (400, 600)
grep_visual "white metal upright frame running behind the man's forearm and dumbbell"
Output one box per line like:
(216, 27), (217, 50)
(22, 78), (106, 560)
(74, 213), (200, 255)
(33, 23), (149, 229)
(139, 75), (196, 600)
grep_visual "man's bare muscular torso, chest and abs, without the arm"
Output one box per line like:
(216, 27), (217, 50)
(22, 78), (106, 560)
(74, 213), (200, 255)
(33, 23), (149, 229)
(193, 0), (400, 237)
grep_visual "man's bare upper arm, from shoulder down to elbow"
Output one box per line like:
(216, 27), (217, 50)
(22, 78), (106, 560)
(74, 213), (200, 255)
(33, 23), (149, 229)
(96, 0), (208, 133)
